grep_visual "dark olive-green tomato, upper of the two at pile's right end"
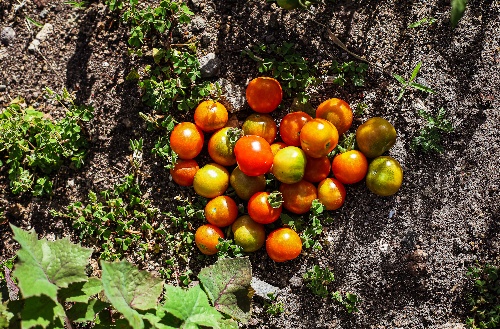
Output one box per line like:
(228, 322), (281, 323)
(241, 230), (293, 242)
(356, 117), (397, 158)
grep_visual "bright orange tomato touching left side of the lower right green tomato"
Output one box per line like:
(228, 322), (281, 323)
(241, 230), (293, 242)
(332, 150), (368, 184)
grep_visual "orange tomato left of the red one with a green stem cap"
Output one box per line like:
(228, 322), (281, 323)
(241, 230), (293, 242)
(205, 195), (238, 227)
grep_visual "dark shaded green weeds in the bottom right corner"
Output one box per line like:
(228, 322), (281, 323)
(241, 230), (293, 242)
(467, 265), (500, 329)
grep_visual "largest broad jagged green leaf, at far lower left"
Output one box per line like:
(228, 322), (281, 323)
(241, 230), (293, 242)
(11, 225), (92, 302)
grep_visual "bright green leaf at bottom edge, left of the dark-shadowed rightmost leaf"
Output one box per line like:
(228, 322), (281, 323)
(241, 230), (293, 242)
(161, 285), (222, 329)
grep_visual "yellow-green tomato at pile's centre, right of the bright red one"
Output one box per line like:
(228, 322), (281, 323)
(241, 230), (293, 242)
(272, 146), (307, 184)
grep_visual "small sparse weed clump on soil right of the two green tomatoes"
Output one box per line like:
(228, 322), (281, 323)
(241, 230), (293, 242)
(411, 108), (453, 153)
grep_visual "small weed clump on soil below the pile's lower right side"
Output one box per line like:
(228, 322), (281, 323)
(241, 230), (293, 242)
(303, 265), (360, 313)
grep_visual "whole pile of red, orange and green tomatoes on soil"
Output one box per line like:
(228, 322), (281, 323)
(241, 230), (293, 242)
(170, 77), (402, 262)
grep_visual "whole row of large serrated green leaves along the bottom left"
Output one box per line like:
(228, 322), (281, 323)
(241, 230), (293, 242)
(0, 226), (252, 329)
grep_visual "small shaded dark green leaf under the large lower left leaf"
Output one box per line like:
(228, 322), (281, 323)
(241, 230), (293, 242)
(21, 295), (65, 329)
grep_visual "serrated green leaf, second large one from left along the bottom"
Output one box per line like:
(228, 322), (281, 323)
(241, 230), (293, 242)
(101, 261), (163, 328)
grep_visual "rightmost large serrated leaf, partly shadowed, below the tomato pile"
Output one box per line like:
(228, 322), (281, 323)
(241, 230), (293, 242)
(198, 257), (252, 323)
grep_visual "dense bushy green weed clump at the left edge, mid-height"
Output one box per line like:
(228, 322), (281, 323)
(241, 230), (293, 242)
(0, 89), (93, 196)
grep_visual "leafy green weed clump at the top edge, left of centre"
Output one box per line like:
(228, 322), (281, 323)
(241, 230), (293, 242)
(121, 0), (193, 48)
